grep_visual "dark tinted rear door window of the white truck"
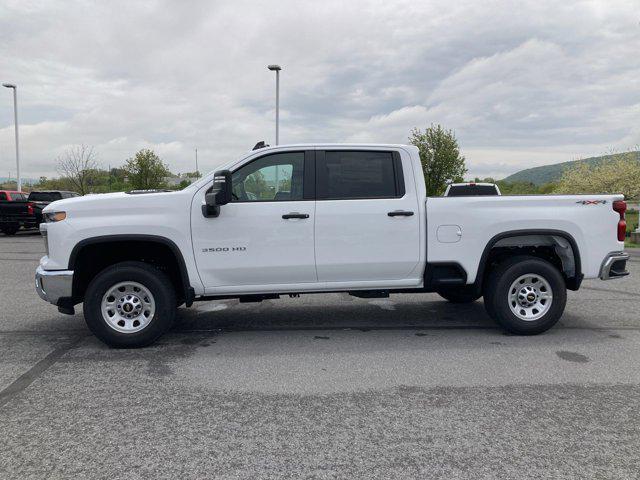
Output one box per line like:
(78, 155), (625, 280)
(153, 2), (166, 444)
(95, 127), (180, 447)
(317, 150), (404, 200)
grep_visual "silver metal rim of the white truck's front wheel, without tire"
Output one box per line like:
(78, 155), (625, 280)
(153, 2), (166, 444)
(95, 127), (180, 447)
(101, 282), (156, 333)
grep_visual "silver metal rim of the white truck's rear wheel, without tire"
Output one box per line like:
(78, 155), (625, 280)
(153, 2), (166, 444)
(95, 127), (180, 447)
(507, 273), (553, 321)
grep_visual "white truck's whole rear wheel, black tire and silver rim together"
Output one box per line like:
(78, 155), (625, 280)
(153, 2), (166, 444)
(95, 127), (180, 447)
(484, 256), (567, 335)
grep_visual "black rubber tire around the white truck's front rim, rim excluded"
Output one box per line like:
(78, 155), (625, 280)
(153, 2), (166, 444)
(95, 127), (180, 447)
(83, 262), (176, 348)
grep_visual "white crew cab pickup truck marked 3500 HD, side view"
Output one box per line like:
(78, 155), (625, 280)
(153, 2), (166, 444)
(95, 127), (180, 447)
(35, 144), (628, 347)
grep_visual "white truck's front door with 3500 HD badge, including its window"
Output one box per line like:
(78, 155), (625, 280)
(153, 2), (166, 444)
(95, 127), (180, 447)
(192, 151), (317, 294)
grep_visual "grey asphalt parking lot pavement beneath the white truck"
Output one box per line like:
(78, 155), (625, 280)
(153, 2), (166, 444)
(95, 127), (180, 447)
(0, 234), (640, 479)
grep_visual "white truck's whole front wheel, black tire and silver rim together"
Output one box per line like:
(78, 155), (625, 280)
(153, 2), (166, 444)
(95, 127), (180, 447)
(84, 262), (176, 348)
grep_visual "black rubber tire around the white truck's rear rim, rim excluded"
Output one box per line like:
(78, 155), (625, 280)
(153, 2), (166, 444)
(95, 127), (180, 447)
(484, 256), (567, 335)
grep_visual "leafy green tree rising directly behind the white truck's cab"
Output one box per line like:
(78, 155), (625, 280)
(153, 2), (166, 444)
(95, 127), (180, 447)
(409, 124), (467, 196)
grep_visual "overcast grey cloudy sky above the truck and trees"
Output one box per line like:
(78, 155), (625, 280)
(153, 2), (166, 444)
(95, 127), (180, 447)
(0, 0), (640, 178)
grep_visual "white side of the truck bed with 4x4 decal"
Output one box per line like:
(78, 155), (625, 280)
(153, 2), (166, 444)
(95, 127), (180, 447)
(426, 195), (624, 283)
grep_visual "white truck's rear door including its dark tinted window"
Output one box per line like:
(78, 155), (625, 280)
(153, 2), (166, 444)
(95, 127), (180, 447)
(315, 149), (421, 283)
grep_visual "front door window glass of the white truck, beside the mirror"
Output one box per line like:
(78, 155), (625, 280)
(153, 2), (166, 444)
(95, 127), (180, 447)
(232, 152), (304, 202)
